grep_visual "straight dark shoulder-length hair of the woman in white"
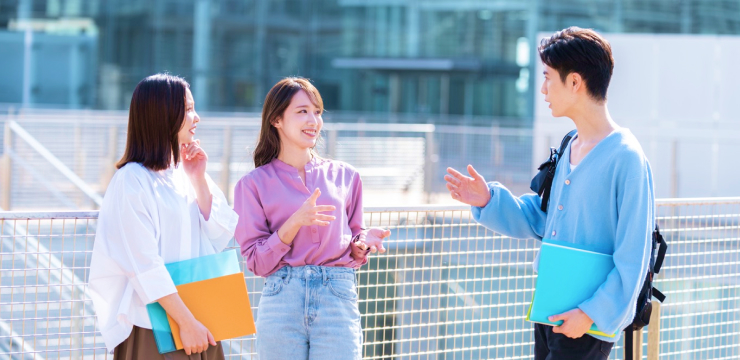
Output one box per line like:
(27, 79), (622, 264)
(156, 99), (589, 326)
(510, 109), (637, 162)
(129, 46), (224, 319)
(116, 74), (190, 171)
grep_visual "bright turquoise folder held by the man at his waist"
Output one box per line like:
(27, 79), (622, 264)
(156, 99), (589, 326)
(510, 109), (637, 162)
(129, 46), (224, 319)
(527, 239), (616, 337)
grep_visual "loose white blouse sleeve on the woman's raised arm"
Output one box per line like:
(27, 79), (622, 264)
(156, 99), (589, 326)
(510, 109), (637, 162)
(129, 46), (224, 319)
(198, 174), (239, 252)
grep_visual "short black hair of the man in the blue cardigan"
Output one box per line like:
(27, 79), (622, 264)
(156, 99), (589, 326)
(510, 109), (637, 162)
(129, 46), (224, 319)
(538, 26), (614, 101)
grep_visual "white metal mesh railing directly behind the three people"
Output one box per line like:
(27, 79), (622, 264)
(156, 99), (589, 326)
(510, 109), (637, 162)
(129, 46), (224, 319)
(0, 198), (740, 359)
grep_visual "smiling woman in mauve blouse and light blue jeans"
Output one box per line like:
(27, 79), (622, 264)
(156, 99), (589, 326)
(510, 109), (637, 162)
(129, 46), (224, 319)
(234, 78), (390, 360)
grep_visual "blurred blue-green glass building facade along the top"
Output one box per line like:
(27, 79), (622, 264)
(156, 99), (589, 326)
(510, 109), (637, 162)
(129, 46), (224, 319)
(0, 0), (740, 125)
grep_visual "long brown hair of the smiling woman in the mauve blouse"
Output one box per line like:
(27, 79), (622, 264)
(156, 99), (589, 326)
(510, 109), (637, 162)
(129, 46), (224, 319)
(254, 77), (324, 168)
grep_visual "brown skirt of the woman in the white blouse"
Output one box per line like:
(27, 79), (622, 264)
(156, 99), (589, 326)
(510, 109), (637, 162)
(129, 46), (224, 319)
(113, 326), (224, 360)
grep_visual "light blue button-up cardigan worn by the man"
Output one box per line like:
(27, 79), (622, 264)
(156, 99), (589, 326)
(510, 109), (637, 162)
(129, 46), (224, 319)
(472, 128), (655, 342)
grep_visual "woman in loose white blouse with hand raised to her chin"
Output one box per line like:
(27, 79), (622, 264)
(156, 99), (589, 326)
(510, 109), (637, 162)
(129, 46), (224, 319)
(89, 74), (238, 360)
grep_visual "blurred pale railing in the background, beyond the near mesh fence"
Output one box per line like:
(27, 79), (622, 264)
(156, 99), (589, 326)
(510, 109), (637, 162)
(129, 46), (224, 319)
(0, 111), (533, 210)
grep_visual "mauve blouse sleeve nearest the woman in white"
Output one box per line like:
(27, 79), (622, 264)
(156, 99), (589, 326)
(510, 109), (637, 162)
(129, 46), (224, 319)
(234, 178), (291, 276)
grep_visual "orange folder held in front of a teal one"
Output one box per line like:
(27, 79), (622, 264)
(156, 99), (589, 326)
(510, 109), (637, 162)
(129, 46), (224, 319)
(167, 273), (257, 350)
